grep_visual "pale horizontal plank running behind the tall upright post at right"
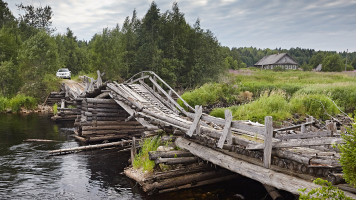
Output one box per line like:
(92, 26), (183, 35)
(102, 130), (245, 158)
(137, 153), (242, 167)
(246, 138), (344, 150)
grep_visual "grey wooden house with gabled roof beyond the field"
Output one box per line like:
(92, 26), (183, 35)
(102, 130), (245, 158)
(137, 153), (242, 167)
(255, 53), (298, 69)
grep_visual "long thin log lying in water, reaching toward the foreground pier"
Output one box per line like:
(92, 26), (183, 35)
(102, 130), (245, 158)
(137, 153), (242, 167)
(48, 140), (132, 155)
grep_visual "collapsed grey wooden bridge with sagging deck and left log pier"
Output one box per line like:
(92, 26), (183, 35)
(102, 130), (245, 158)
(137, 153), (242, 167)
(48, 71), (356, 198)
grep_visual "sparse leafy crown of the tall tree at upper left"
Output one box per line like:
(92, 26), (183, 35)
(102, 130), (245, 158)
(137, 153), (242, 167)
(16, 3), (56, 33)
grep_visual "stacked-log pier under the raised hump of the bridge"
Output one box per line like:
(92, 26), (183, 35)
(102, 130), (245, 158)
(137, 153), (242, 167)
(75, 98), (146, 142)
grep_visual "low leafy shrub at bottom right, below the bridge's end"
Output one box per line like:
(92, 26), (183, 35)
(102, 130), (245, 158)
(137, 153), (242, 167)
(299, 178), (352, 200)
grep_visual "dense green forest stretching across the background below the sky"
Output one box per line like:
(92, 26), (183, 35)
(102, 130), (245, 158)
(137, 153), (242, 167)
(0, 0), (356, 101)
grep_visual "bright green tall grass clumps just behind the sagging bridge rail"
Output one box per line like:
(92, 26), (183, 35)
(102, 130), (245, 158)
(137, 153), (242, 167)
(210, 90), (340, 123)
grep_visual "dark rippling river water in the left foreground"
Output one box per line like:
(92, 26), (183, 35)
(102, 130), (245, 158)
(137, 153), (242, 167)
(0, 113), (294, 200)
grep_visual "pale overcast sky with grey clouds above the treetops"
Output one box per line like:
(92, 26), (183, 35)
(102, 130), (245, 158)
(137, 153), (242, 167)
(5, 0), (356, 52)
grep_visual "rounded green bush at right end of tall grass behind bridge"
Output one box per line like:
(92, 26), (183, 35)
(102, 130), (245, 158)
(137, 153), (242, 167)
(290, 94), (340, 119)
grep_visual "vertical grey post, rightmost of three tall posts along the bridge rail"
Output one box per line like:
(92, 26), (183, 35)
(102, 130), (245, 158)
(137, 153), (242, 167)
(263, 116), (273, 169)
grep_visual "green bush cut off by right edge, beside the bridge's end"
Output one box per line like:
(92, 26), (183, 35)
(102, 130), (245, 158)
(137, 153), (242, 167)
(338, 123), (356, 187)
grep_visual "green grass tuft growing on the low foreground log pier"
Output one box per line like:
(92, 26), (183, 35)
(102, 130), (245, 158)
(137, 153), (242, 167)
(133, 136), (161, 172)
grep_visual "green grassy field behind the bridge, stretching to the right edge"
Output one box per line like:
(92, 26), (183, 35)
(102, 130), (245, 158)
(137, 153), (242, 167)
(180, 70), (356, 122)
